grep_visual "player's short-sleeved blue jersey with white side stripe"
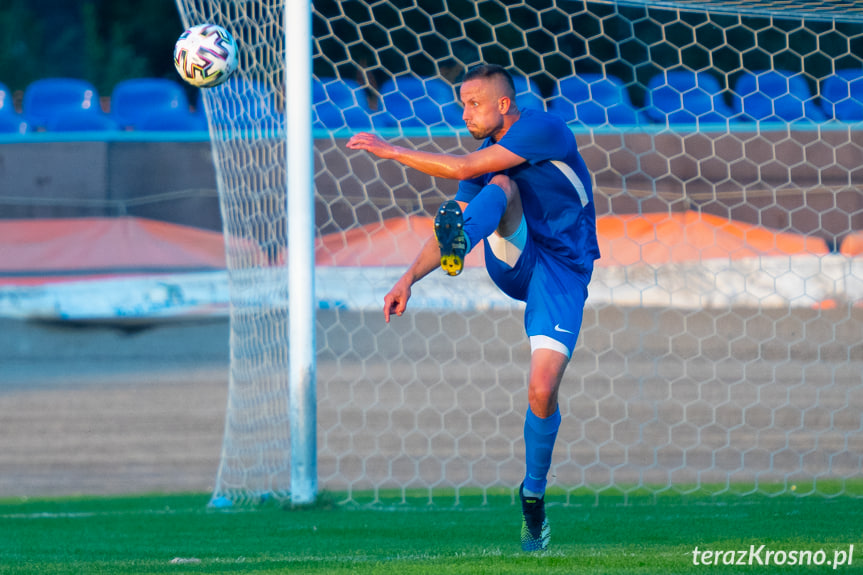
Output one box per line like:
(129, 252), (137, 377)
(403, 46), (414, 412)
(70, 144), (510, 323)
(455, 109), (599, 271)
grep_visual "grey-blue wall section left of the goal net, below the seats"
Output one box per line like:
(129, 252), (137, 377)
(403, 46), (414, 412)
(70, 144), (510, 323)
(0, 141), (221, 230)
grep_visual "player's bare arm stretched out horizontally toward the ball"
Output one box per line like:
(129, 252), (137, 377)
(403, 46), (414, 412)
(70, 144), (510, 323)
(347, 132), (525, 180)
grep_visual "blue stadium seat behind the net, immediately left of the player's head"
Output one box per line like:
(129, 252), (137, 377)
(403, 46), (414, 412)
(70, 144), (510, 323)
(380, 75), (464, 128)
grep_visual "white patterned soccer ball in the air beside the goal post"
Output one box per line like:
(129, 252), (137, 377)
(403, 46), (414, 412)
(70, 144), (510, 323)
(174, 24), (238, 88)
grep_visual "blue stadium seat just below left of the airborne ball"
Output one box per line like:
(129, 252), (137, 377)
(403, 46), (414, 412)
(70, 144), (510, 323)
(111, 78), (189, 129)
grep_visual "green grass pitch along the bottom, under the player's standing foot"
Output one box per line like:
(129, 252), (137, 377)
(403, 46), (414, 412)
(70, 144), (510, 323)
(0, 491), (863, 575)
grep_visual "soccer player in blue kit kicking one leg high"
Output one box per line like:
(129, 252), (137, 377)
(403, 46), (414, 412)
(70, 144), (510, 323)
(347, 64), (599, 551)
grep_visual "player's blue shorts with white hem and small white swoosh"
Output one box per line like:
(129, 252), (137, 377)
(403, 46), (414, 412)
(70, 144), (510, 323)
(484, 224), (591, 357)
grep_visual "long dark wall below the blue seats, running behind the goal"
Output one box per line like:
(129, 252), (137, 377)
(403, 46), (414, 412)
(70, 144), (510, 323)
(0, 126), (863, 245)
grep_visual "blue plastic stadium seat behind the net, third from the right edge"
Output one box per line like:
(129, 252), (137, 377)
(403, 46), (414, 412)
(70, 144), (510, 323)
(645, 70), (734, 124)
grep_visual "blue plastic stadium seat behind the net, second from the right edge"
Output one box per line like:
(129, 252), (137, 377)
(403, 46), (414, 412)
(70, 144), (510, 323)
(732, 70), (827, 122)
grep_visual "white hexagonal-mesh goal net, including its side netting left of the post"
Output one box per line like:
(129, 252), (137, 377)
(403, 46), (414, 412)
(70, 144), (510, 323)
(178, 0), (863, 502)
